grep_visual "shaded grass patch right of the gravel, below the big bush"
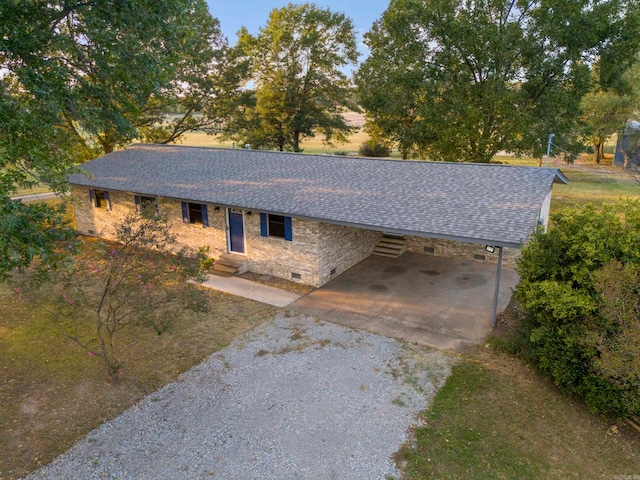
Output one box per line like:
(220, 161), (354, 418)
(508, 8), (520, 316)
(398, 347), (640, 480)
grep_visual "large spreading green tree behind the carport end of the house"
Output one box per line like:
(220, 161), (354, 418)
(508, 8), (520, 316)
(356, 0), (639, 162)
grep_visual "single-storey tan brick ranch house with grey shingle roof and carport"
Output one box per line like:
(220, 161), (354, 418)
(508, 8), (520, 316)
(70, 145), (567, 286)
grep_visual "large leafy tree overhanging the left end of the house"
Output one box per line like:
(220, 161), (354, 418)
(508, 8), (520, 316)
(0, 0), (237, 277)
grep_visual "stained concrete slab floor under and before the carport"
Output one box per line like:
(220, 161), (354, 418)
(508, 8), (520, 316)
(289, 253), (519, 351)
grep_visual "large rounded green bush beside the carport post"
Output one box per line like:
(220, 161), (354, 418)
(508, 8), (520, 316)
(516, 201), (640, 415)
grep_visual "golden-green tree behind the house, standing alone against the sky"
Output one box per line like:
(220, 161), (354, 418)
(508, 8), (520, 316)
(228, 3), (358, 152)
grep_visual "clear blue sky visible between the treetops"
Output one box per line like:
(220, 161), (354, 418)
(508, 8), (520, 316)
(207, 0), (389, 51)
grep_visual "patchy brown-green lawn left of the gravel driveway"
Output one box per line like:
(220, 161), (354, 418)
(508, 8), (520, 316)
(0, 264), (275, 479)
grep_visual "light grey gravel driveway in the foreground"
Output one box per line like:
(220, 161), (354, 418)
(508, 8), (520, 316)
(28, 314), (455, 480)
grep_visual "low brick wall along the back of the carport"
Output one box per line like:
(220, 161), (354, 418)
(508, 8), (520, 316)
(405, 235), (520, 267)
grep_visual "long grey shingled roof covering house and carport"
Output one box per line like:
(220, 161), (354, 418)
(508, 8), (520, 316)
(70, 144), (567, 247)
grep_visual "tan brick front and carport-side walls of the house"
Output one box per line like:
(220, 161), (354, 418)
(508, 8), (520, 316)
(72, 186), (380, 287)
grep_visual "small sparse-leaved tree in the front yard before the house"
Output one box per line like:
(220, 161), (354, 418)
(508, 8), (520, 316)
(18, 214), (208, 378)
